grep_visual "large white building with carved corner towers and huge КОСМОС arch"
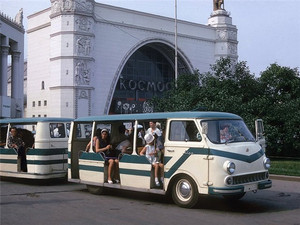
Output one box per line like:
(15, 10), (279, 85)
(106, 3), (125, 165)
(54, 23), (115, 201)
(26, 0), (238, 118)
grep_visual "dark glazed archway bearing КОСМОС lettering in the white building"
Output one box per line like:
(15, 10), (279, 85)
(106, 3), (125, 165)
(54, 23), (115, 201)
(109, 43), (190, 114)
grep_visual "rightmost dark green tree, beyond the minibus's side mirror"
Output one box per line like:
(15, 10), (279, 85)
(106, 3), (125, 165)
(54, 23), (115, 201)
(259, 63), (300, 156)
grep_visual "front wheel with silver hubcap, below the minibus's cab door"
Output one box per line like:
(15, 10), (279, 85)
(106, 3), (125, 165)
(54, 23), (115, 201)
(172, 176), (199, 208)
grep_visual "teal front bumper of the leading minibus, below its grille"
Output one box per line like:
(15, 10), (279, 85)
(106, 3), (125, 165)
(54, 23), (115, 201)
(208, 180), (272, 195)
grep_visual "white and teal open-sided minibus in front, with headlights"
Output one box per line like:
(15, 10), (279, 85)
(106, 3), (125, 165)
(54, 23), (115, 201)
(68, 111), (272, 208)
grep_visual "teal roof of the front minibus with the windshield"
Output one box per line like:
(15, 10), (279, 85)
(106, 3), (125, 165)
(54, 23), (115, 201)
(74, 111), (241, 122)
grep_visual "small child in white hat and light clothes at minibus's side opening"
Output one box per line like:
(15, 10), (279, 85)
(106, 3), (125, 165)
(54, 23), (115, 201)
(140, 134), (164, 186)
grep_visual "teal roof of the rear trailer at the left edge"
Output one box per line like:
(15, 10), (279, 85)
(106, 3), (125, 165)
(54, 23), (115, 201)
(0, 117), (73, 124)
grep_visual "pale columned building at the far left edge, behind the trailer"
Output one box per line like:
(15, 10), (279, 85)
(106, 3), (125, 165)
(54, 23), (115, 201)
(0, 9), (25, 118)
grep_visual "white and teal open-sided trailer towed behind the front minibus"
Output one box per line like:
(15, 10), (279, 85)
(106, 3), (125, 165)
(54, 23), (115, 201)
(0, 117), (72, 179)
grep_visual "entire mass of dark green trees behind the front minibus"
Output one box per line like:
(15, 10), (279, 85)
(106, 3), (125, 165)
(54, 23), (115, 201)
(153, 58), (300, 156)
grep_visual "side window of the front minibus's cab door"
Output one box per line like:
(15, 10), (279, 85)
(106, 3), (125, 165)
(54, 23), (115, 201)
(169, 121), (201, 141)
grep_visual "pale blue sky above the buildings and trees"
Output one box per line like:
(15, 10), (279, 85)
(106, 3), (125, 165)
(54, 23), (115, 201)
(0, 0), (300, 76)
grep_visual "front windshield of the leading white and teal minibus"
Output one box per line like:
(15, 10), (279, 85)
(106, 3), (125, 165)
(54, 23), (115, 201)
(201, 120), (255, 144)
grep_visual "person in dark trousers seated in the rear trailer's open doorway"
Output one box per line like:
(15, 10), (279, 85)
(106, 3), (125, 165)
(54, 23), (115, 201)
(7, 127), (27, 172)
